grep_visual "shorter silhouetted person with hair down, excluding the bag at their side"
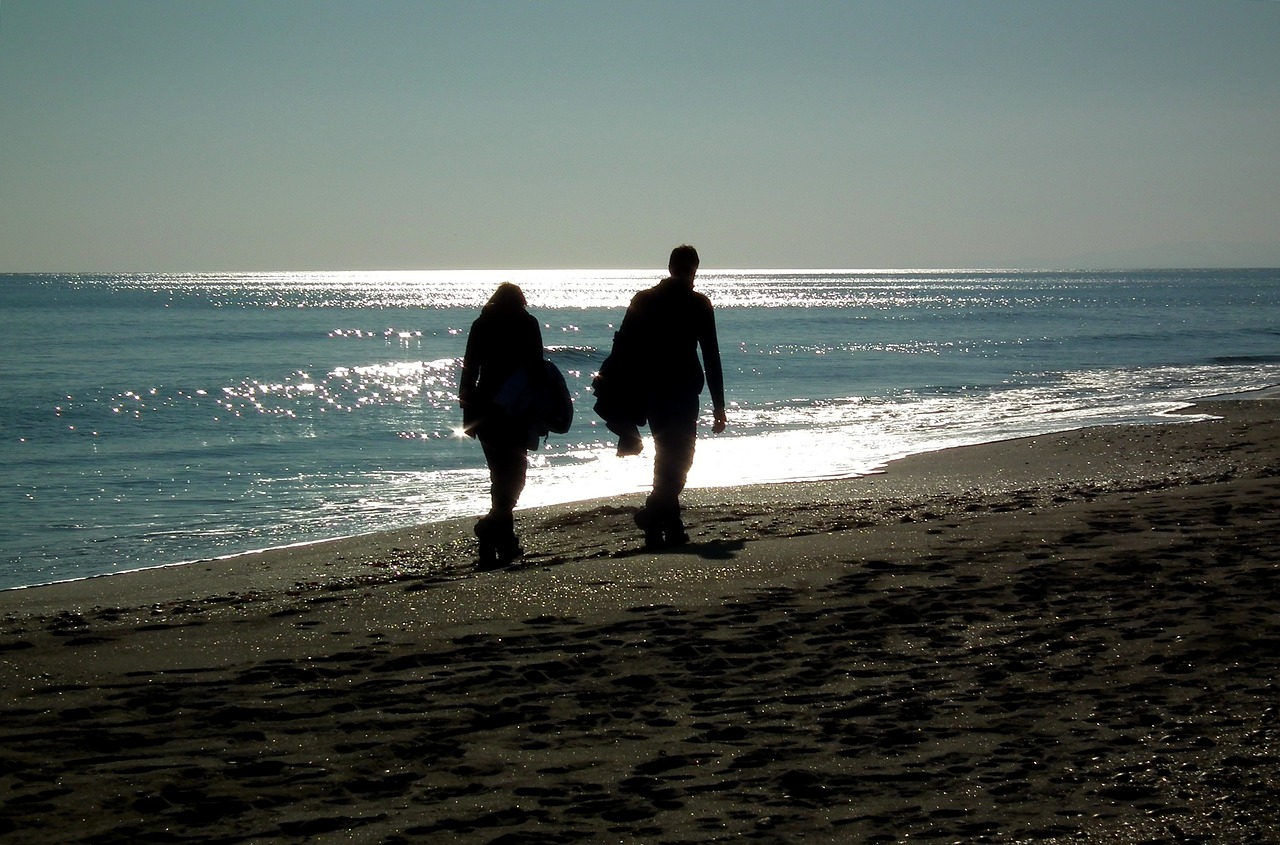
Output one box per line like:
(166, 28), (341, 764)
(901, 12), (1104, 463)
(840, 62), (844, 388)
(458, 282), (542, 563)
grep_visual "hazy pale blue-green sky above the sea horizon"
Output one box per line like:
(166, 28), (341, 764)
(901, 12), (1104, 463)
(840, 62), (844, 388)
(0, 0), (1280, 271)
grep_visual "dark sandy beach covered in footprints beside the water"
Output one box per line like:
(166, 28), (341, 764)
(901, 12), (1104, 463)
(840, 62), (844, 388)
(0, 399), (1280, 845)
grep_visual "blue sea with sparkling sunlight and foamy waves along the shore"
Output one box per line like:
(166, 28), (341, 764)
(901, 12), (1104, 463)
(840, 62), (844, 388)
(0, 269), (1280, 589)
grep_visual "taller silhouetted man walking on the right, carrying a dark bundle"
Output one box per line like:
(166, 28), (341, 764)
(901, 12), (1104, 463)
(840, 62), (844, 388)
(594, 246), (726, 548)
